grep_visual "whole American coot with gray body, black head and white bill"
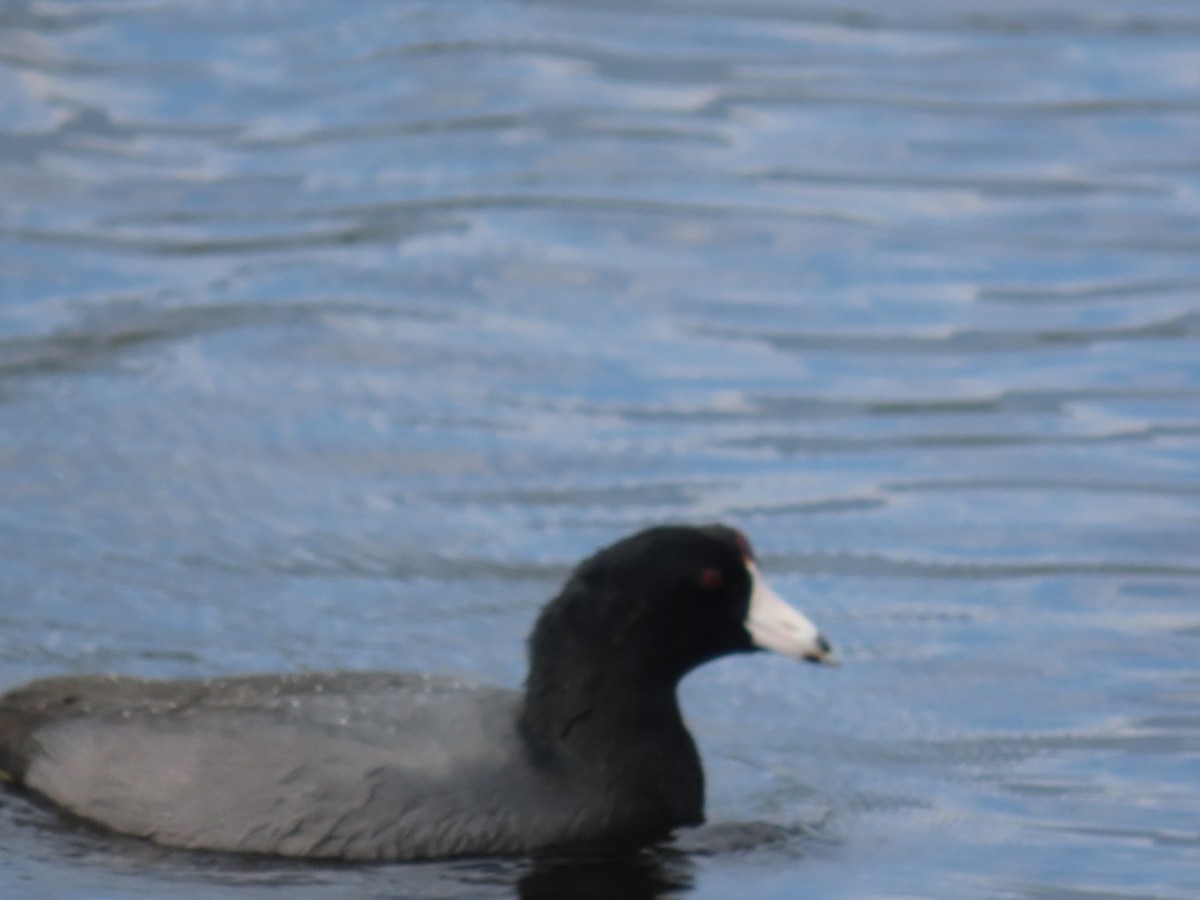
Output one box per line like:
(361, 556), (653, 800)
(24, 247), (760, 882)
(0, 526), (832, 859)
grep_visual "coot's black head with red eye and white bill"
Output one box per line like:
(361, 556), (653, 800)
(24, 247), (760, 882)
(530, 526), (832, 686)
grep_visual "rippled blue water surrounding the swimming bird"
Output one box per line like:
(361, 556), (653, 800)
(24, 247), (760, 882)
(0, 0), (1200, 900)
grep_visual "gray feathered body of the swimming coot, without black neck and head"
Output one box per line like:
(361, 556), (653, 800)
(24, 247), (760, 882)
(0, 672), (698, 859)
